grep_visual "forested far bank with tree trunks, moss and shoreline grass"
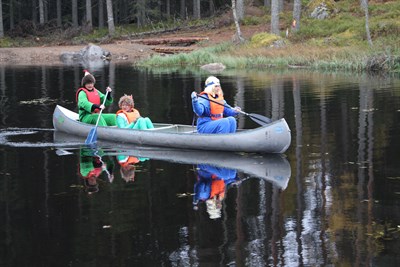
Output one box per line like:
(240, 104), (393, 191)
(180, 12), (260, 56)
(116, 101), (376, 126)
(0, 0), (400, 72)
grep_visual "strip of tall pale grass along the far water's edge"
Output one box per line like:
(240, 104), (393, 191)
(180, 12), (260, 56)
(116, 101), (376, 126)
(137, 43), (400, 72)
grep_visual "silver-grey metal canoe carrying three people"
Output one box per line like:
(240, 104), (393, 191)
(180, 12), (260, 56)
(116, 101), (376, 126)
(53, 105), (291, 153)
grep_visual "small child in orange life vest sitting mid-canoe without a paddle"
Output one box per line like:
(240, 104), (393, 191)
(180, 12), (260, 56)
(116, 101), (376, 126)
(117, 95), (154, 130)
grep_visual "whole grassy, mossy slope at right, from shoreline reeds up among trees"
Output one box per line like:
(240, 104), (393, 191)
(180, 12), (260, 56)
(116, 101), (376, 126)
(138, 0), (400, 72)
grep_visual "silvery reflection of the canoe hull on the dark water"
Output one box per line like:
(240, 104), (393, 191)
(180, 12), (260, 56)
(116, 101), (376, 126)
(54, 131), (291, 190)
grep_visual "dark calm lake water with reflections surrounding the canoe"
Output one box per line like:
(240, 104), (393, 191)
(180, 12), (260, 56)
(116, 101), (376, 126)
(0, 65), (400, 266)
